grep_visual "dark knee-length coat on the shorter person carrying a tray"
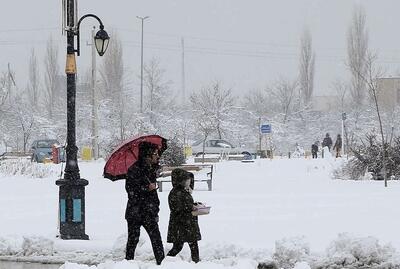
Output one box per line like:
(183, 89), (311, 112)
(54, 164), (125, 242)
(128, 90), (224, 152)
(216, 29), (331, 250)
(167, 186), (201, 243)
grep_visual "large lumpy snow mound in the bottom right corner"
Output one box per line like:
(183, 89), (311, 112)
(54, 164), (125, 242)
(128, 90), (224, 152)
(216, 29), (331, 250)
(316, 233), (400, 269)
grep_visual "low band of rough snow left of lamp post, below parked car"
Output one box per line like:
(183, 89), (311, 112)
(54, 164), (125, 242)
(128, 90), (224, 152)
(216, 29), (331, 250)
(0, 159), (60, 178)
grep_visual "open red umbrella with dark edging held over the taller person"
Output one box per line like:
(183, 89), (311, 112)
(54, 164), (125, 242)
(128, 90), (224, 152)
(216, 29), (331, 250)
(103, 135), (167, 181)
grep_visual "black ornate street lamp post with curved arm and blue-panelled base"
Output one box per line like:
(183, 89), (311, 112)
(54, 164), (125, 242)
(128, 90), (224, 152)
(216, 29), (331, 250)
(56, 0), (110, 240)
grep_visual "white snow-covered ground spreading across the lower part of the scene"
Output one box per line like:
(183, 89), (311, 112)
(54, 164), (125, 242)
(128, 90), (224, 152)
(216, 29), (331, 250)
(0, 158), (400, 269)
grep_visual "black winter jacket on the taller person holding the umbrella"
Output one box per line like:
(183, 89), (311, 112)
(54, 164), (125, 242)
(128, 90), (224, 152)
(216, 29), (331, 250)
(125, 161), (160, 220)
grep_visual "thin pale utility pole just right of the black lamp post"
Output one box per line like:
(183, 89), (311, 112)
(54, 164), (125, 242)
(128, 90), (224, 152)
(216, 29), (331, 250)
(90, 27), (99, 160)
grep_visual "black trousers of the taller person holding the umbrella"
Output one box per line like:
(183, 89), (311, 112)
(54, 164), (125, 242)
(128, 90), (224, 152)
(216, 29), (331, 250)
(126, 218), (164, 264)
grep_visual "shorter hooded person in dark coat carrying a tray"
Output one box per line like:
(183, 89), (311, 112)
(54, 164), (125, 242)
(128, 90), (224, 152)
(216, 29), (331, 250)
(167, 168), (201, 263)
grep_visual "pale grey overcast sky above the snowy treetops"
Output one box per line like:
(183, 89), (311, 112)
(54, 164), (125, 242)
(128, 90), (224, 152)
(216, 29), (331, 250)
(0, 0), (400, 98)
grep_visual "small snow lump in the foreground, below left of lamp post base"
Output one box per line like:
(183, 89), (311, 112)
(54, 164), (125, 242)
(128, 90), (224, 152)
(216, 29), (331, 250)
(22, 236), (54, 256)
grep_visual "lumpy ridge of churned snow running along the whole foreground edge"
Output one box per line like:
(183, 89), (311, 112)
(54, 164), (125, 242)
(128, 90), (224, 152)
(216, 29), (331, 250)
(0, 233), (400, 269)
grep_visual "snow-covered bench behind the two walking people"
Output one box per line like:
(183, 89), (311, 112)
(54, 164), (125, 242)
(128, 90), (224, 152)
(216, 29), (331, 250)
(157, 164), (214, 192)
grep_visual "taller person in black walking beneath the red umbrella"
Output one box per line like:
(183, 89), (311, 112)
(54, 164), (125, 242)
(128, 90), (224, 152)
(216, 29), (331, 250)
(125, 142), (164, 265)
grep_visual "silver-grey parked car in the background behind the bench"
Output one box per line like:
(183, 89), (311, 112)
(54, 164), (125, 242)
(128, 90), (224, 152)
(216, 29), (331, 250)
(192, 139), (253, 157)
